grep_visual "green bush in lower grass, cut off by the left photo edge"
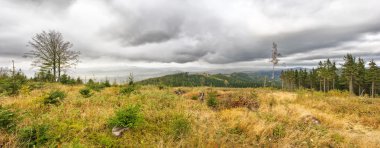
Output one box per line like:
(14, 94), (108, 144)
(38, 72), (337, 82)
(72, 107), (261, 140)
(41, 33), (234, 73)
(0, 106), (16, 131)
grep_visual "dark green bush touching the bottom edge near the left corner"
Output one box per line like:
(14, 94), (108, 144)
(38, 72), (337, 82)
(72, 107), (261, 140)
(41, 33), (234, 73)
(18, 125), (49, 147)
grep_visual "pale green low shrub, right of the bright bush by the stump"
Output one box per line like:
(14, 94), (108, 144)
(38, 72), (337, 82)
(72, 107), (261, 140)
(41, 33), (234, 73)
(171, 115), (191, 139)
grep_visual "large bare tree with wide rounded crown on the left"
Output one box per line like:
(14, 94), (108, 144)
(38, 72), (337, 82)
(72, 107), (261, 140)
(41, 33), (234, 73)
(25, 31), (80, 81)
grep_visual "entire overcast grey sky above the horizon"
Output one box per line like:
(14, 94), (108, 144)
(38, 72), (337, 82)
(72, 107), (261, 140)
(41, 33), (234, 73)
(0, 0), (380, 80)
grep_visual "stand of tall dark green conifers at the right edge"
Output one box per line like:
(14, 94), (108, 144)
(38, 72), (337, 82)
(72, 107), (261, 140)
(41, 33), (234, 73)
(280, 54), (380, 97)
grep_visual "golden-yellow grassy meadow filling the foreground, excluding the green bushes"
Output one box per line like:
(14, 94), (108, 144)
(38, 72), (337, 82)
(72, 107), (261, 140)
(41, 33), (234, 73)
(0, 84), (380, 147)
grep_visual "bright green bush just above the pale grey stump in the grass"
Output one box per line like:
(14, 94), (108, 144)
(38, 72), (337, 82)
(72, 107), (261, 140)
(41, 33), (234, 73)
(108, 105), (143, 128)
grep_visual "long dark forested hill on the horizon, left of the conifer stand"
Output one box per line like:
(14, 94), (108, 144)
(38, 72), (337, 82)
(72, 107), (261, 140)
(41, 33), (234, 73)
(137, 72), (279, 87)
